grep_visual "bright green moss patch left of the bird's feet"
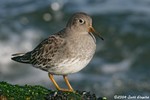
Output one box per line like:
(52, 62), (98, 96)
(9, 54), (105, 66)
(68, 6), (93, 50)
(0, 82), (52, 100)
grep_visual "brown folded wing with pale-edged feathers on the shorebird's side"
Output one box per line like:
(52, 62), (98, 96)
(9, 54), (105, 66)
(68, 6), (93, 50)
(31, 35), (65, 66)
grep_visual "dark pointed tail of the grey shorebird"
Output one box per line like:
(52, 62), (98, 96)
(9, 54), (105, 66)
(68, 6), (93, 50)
(11, 53), (30, 64)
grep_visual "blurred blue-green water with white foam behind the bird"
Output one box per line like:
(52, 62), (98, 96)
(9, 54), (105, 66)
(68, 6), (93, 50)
(0, 0), (150, 98)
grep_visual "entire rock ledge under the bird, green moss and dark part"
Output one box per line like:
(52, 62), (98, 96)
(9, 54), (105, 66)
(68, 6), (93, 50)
(0, 82), (106, 100)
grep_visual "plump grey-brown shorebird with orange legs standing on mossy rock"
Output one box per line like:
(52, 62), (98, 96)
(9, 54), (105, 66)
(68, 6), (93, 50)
(11, 12), (104, 92)
